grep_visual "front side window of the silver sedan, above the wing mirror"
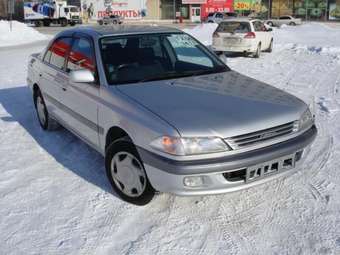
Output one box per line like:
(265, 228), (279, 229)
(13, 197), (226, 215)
(67, 38), (96, 74)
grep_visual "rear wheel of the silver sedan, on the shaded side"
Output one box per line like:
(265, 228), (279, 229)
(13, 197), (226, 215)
(34, 90), (59, 131)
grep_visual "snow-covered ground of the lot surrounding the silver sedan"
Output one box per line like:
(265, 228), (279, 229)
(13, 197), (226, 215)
(0, 24), (340, 255)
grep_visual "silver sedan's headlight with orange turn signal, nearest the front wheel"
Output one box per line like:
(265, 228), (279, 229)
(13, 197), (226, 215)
(150, 136), (230, 156)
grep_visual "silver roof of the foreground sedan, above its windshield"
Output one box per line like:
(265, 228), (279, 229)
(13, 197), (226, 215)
(58, 25), (182, 38)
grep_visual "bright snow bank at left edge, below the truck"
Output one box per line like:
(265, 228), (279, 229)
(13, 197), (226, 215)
(0, 20), (47, 47)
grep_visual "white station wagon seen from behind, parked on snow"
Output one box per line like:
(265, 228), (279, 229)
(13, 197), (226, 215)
(212, 19), (273, 58)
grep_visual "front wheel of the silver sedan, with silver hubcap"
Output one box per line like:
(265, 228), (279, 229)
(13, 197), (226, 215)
(105, 138), (155, 206)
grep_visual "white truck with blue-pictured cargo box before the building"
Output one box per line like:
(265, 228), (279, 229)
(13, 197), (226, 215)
(24, 0), (81, 27)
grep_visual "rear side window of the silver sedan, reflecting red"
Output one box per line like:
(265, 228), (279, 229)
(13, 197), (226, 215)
(44, 37), (72, 69)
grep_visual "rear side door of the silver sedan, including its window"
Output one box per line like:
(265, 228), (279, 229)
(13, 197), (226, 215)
(39, 37), (72, 120)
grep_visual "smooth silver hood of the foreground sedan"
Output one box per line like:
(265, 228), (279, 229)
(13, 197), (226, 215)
(118, 71), (307, 138)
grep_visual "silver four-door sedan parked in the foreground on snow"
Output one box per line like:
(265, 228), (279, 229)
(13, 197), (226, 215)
(27, 26), (317, 205)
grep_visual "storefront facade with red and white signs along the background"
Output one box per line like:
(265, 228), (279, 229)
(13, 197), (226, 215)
(79, 0), (340, 22)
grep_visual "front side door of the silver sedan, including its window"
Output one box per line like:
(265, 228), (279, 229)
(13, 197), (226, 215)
(62, 34), (103, 148)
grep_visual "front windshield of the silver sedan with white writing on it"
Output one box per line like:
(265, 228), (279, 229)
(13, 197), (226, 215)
(100, 33), (229, 85)
